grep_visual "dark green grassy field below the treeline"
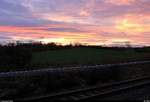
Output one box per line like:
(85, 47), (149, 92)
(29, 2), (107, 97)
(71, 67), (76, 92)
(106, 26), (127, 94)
(30, 48), (150, 67)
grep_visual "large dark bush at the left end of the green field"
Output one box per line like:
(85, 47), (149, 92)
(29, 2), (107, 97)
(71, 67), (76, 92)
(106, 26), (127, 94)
(0, 46), (32, 71)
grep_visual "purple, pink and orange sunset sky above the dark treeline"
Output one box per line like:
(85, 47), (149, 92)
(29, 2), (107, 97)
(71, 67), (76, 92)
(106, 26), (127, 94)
(0, 0), (150, 46)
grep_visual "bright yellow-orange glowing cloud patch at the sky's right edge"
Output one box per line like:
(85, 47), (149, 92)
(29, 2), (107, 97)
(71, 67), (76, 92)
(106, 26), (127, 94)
(115, 14), (150, 34)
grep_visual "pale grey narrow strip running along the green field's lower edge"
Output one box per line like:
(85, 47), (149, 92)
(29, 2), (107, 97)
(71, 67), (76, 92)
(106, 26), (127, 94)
(0, 60), (150, 78)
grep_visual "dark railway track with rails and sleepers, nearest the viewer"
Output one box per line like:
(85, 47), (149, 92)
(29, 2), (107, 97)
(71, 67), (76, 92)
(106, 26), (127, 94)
(16, 76), (150, 101)
